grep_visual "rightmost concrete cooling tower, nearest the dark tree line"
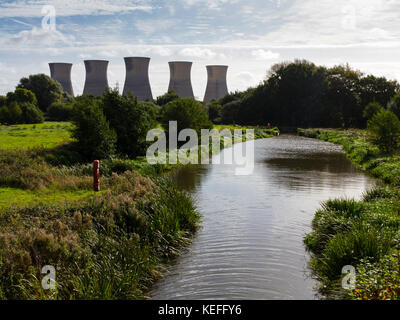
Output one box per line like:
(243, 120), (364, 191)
(204, 66), (228, 103)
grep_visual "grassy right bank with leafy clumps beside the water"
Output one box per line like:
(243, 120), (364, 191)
(299, 129), (400, 300)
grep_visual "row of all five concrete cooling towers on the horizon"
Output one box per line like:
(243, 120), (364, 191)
(49, 57), (228, 103)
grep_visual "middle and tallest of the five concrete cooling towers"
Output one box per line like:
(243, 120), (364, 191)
(124, 57), (153, 101)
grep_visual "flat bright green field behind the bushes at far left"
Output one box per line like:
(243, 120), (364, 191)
(0, 122), (72, 149)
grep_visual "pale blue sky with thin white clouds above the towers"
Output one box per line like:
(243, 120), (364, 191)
(0, 0), (400, 100)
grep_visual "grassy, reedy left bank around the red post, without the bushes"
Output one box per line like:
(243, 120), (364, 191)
(0, 123), (276, 299)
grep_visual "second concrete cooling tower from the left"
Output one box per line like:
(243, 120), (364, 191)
(83, 60), (108, 97)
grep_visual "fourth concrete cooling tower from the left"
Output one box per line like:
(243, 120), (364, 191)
(168, 61), (194, 99)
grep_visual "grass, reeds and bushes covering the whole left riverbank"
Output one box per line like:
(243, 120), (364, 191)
(0, 77), (278, 299)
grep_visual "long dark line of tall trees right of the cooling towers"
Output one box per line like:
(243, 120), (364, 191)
(208, 60), (400, 128)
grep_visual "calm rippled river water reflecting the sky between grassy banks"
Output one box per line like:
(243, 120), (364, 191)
(150, 135), (374, 300)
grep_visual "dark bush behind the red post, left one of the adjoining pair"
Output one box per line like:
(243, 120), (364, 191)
(72, 96), (117, 160)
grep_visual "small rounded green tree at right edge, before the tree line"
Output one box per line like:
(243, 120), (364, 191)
(367, 110), (400, 153)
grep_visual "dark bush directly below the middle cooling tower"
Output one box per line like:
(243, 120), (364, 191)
(101, 90), (156, 158)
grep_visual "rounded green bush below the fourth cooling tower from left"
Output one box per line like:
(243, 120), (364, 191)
(161, 98), (213, 136)
